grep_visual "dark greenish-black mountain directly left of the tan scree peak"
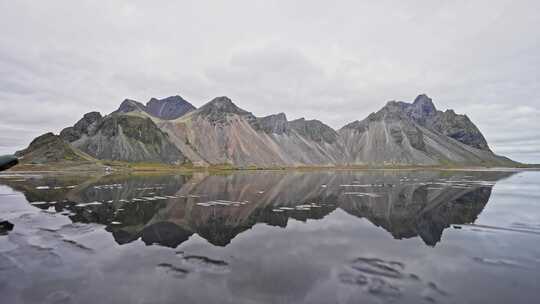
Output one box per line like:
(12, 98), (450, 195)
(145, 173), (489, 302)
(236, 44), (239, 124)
(60, 111), (185, 164)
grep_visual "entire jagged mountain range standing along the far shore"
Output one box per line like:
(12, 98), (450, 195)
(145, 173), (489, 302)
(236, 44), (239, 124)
(17, 94), (517, 168)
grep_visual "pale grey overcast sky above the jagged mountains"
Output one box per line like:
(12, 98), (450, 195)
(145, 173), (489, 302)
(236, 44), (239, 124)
(0, 0), (540, 162)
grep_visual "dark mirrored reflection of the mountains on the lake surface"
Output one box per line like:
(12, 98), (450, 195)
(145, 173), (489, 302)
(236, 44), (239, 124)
(2, 171), (512, 247)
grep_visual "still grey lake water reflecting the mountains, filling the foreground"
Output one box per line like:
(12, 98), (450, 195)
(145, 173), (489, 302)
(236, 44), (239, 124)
(0, 171), (540, 304)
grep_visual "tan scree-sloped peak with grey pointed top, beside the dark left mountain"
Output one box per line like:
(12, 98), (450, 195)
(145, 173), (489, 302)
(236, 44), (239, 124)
(158, 97), (283, 166)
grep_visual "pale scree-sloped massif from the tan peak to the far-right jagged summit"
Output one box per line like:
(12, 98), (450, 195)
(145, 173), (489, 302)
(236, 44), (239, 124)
(158, 95), (515, 167)
